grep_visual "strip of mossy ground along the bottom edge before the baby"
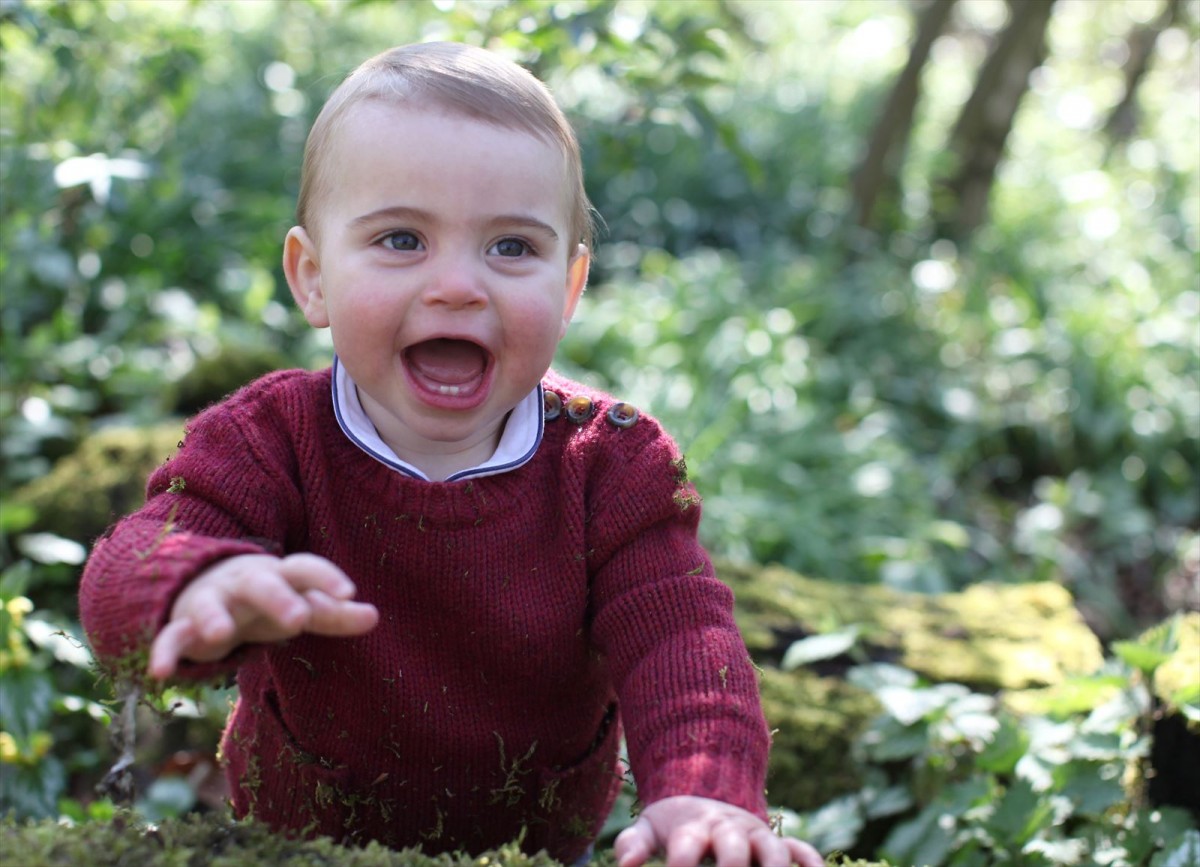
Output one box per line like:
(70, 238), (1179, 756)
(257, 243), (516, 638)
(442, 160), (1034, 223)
(0, 813), (888, 867)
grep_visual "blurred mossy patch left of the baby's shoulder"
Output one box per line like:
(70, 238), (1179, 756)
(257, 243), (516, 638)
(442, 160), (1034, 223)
(13, 421), (184, 542)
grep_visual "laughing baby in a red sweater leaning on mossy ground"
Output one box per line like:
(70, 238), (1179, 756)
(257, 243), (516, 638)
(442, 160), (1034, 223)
(80, 43), (823, 867)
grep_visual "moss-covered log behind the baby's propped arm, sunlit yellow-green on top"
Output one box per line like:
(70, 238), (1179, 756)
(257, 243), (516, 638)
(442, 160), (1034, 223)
(718, 564), (1103, 811)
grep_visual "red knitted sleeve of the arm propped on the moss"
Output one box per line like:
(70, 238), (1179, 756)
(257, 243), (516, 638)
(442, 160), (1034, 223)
(589, 425), (769, 818)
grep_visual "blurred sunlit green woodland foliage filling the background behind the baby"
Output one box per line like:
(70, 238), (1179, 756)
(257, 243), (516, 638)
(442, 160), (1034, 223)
(0, 0), (1200, 854)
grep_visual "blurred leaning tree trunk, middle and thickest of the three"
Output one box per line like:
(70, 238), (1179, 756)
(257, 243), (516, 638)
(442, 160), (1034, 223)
(934, 0), (1055, 240)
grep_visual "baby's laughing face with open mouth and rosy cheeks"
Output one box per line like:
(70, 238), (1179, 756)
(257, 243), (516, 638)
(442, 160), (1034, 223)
(286, 102), (588, 472)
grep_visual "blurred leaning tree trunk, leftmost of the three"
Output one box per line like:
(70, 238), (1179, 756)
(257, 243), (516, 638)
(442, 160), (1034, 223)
(853, 0), (954, 228)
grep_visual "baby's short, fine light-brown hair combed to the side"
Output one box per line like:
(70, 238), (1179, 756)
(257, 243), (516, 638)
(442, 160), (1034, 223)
(296, 42), (595, 249)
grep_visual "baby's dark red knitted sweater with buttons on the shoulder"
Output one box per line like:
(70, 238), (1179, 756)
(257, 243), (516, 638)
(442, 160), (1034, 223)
(80, 370), (768, 861)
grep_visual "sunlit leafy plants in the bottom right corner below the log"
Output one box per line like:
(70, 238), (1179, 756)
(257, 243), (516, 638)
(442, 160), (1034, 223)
(785, 615), (1200, 867)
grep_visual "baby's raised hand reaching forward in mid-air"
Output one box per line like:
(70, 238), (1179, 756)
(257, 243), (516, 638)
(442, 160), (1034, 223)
(149, 554), (379, 680)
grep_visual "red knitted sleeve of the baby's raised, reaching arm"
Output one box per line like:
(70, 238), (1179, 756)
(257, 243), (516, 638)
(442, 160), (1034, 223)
(79, 374), (302, 678)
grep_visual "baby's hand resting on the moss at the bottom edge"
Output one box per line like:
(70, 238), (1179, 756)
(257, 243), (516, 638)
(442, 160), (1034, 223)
(613, 795), (824, 867)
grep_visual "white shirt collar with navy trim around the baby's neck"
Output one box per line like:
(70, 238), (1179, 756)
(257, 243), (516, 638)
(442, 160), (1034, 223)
(332, 355), (545, 482)
